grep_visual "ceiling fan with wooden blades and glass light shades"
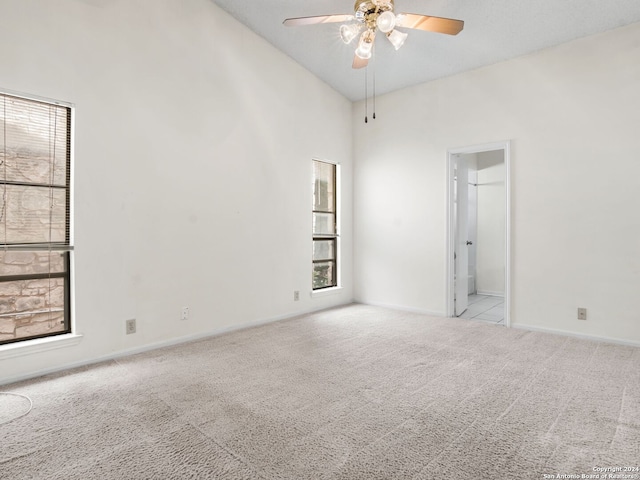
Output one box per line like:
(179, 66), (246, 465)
(284, 0), (464, 68)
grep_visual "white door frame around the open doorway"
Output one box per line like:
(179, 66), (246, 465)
(446, 140), (511, 327)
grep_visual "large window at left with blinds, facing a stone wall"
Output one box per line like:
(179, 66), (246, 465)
(0, 93), (72, 345)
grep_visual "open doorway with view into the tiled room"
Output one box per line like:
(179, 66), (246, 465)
(447, 142), (510, 326)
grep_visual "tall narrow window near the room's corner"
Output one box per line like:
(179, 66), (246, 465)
(313, 160), (338, 290)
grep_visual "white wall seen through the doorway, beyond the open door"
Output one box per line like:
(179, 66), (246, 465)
(474, 150), (506, 295)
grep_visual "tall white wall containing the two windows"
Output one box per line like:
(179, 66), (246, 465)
(0, 0), (353, 382)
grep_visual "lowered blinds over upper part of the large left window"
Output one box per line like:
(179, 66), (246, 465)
(0, 95), (71, 248)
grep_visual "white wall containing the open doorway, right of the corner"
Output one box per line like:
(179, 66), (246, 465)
(354, 23), (640, 343)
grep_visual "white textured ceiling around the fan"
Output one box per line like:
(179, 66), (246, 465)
(212, 0), (640, 100)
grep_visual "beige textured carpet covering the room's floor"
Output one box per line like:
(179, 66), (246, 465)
(0, 305), (640, 480)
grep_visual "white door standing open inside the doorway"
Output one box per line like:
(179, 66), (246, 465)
(455, 155), (469, 316)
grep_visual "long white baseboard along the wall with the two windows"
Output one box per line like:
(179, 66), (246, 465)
(0, 302), (352, 385)
